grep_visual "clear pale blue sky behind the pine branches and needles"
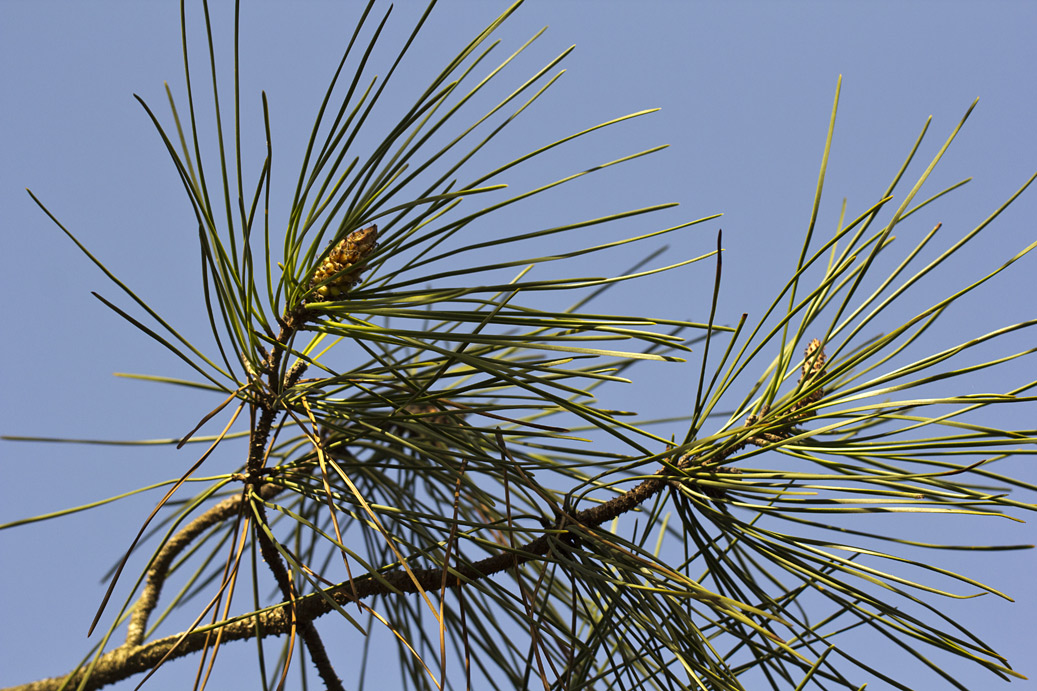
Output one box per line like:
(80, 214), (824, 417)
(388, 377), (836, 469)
(0, 0), (1037, 689)
